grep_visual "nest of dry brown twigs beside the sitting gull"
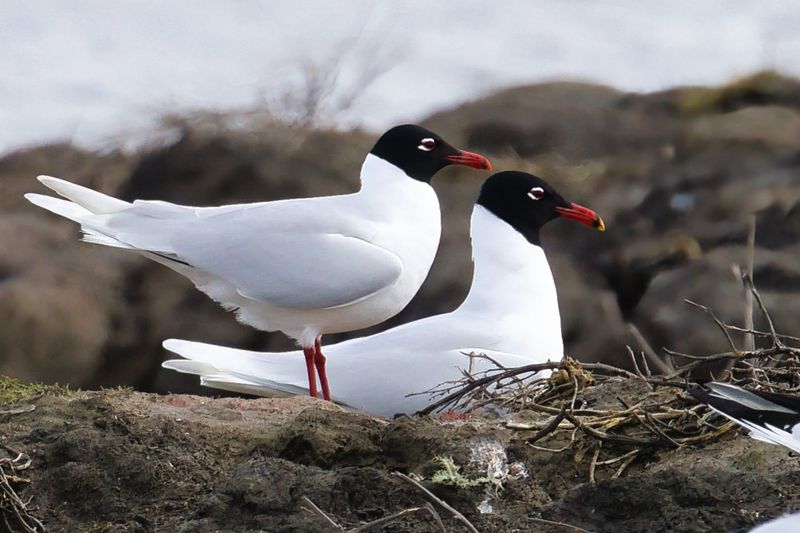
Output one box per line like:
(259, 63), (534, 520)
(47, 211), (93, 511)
(421, 284), (800, 481)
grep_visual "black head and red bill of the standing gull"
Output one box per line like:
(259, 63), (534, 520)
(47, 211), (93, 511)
(370, 124), (492, 182)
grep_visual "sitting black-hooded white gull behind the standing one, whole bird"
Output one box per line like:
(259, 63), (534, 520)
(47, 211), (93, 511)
(163, 172), (605, 416)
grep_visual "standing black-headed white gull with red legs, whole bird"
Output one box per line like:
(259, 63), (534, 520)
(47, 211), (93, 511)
(25, 125), (491, 399)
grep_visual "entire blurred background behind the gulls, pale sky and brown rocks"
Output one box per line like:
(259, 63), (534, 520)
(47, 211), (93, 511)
(0, 0), (800, 391)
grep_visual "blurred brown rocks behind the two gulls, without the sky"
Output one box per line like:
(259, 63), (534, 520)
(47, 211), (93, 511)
(0, 71), (800, 392)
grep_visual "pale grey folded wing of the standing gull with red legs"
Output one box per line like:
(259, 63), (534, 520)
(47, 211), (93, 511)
(99, 197), (403, 309)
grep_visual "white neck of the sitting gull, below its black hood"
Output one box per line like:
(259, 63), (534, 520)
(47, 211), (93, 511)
(458, 205), (561, 322)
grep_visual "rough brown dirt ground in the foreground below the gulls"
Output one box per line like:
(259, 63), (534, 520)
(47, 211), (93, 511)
(0, 381), (800, 532)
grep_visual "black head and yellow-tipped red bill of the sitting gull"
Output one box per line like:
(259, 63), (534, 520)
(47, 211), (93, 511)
(477, 171), (606, 244)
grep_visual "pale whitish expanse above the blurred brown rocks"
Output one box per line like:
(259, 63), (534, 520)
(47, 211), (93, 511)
(0, 0), (800, 153)
